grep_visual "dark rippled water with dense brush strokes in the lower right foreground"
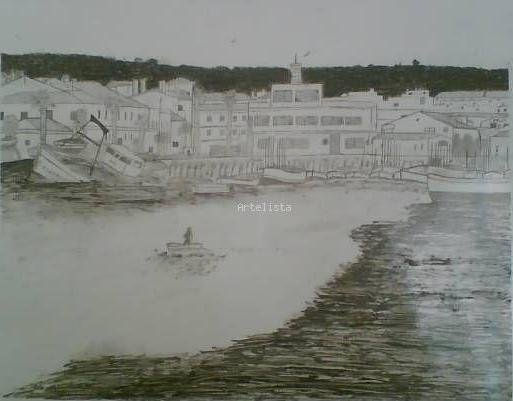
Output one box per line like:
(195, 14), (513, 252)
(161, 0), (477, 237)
(10, 195), (512, 401)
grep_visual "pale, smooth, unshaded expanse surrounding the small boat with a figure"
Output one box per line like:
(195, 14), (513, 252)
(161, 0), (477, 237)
(0, 182), (429, 394)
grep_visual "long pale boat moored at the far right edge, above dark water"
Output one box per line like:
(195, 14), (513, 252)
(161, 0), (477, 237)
(427, 174), (511, 194)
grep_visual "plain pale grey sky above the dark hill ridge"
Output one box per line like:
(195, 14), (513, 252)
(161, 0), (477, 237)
(0, 0), (513, 68)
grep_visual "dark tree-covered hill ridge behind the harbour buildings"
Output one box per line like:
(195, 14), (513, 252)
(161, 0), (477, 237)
(2, 53), (508, 96)
